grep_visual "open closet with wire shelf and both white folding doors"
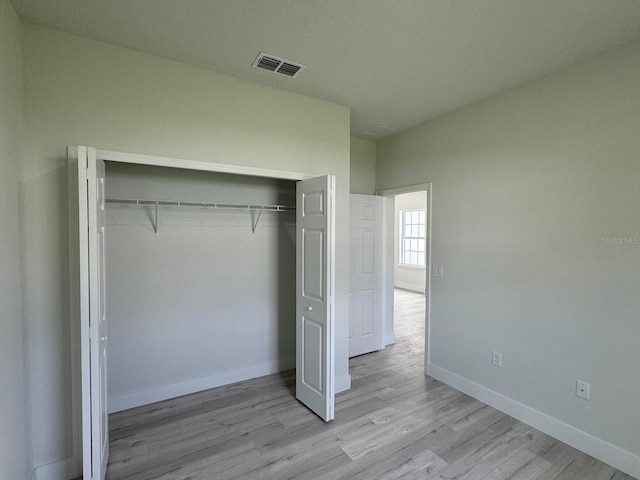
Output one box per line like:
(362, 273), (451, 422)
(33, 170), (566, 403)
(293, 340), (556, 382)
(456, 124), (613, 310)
(69, 147), (335, 479)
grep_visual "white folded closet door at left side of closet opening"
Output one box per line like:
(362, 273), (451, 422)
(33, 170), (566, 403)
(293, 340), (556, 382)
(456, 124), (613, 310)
(78, 147), (109, 480)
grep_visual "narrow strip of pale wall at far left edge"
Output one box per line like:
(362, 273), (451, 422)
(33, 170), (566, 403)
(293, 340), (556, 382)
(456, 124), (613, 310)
(0, 0), (28, 479)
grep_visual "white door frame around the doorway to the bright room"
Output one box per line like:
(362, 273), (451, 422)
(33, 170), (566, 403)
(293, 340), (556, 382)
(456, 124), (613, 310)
(376, 182), (433, 375)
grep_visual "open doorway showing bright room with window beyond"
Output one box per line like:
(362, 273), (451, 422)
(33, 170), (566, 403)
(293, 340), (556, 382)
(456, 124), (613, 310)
(380, 184), (431, 374)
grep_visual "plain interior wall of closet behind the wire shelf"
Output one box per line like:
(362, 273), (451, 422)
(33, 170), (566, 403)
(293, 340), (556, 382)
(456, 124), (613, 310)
(105, 162), (296, 412)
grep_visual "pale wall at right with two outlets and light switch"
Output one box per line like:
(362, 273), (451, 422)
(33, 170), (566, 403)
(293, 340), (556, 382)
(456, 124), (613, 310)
(377, 40), (640, 455)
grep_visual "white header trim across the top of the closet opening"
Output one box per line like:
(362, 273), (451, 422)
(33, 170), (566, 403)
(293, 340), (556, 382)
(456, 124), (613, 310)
(97, 150), (317, 180)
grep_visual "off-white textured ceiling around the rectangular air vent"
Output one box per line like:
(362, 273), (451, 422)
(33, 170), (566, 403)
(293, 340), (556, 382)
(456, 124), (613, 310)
(13, 0), (640, 135)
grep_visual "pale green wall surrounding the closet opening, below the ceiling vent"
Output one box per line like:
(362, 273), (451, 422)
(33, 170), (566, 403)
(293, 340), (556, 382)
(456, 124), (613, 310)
(24, 25), (350, 465)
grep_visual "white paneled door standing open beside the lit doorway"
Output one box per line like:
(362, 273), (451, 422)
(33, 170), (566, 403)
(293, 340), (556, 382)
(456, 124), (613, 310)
(349, 194), (383, 357)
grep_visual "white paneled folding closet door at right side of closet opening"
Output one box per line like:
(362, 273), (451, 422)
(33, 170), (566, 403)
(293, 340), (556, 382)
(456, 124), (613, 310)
(296, 175), (335, 422)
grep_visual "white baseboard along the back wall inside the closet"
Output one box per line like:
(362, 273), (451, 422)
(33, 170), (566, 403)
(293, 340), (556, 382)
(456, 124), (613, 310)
(108, 357), (296, 413)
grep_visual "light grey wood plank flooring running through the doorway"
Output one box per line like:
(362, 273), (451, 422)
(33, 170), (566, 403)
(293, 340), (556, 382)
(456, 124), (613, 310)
(101, 290), (632, 480)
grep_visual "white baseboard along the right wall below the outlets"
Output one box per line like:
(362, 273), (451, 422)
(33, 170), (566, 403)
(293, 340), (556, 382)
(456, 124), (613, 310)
(428, 363), (640, 478)
